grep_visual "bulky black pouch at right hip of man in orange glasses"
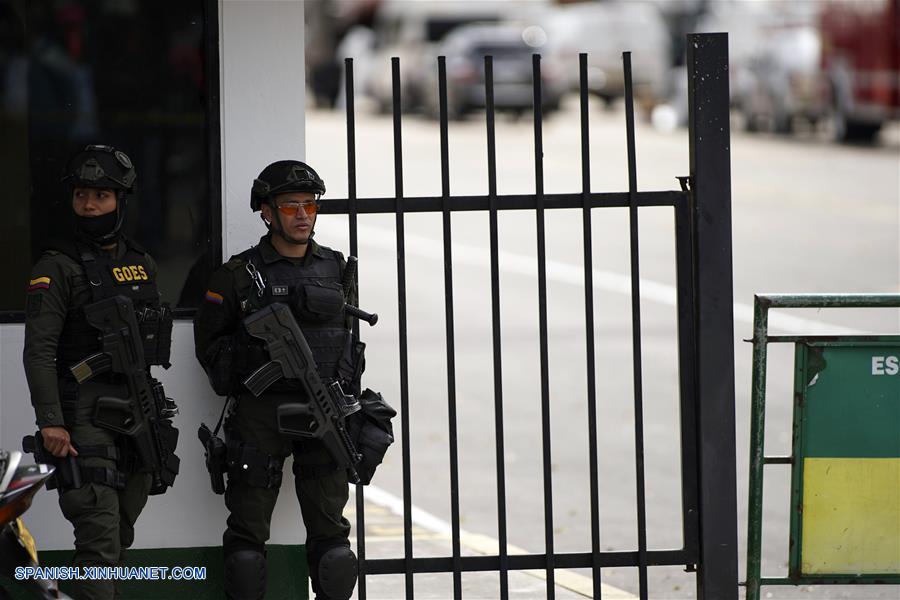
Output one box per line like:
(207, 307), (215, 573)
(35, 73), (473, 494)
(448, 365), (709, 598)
(347, 388), (397, 485)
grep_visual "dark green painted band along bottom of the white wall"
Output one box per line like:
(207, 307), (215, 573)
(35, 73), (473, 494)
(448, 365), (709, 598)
(2, 545), (309, 600)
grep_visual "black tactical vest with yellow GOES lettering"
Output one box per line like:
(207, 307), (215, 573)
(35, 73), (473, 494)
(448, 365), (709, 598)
(50, 238), (172, 376)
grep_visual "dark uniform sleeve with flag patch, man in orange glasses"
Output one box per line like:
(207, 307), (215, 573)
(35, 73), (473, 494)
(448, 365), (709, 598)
(194, 259), (240, 372)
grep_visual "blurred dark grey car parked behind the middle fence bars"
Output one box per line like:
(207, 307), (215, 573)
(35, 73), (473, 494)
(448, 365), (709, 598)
(424, 24), (565, 119)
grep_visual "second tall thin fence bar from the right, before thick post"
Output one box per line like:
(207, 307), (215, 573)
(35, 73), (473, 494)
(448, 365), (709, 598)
(578, 53), (601, 600)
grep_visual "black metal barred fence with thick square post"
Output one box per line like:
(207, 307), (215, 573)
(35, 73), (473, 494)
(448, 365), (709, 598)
(322, 34), (737, 600)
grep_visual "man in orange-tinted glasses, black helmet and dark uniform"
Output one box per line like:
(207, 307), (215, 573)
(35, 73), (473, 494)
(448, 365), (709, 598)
(194, 160), (357, 600)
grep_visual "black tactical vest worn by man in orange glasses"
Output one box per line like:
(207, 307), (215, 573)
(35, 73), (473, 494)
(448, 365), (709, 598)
(235, 241), (350, 382)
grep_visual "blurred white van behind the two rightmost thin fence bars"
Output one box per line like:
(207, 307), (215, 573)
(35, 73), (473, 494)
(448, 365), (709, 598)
(540, 0), (671, 107)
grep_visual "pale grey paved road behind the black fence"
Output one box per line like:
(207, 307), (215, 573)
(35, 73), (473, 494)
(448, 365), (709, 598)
(307, 102), (900, 599)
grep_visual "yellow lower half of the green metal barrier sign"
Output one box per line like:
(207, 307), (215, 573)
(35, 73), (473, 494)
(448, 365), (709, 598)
(801, 458), (900, 575)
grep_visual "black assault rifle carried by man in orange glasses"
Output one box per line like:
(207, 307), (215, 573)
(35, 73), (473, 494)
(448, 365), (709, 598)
(244, 302), (362, 483)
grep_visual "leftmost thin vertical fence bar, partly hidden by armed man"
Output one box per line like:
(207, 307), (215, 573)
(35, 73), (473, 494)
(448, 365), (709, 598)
(344, 58), (366, 600)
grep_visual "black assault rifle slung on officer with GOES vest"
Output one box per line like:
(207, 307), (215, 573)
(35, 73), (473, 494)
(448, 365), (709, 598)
(70, 296), (180, 494)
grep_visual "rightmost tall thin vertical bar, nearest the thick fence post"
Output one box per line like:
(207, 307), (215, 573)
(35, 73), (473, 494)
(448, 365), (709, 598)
(622, 52), (648, 600)
